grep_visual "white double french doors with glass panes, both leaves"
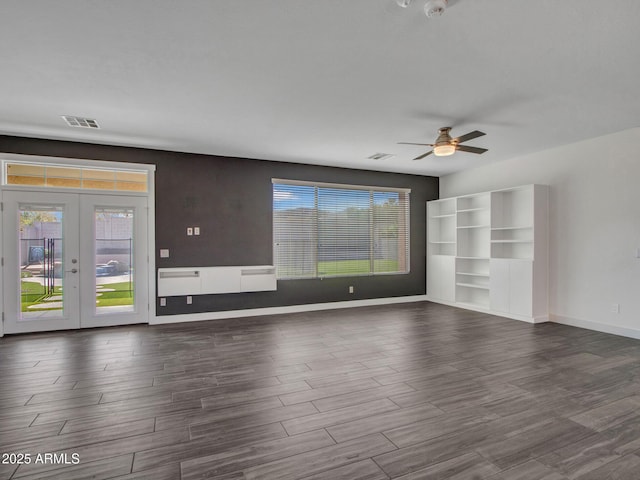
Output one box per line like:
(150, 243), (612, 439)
(2, 190), (149, 333)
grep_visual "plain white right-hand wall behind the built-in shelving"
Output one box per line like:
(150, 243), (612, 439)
(440, 128), (640, 338)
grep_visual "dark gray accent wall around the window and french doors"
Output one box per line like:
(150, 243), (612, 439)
(0, 136), (438, 315)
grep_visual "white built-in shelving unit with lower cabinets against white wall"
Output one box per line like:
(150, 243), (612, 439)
(427, 185), (548, 322)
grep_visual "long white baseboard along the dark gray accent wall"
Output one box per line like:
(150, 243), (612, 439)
(149, 295), (427, 325)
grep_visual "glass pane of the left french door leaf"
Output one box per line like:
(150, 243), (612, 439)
(18, 204), (64, 320)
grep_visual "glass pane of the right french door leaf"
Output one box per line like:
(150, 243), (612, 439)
(95, 207), (135, 314)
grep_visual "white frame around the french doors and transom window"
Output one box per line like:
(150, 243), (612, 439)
(0, 153), (156, 337)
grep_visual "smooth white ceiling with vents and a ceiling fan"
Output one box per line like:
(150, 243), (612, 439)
(0, 0), (640, 176)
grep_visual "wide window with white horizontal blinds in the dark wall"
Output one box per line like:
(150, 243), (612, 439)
(273, 179), (410, 279)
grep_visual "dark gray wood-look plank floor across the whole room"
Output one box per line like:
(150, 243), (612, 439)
(0, 302), (640, 480)
